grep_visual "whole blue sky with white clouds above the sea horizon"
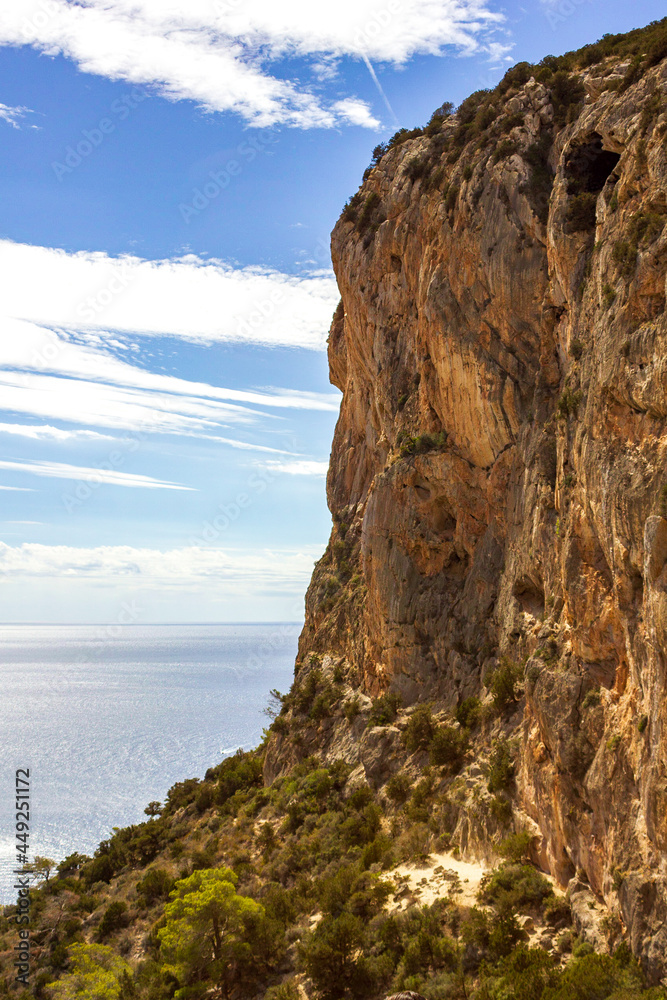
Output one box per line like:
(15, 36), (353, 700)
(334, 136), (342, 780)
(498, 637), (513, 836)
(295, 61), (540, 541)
(0, 0), (664, 623)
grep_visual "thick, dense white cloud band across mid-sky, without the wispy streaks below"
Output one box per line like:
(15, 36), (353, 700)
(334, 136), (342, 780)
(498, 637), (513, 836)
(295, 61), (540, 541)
(0, 240), (340, 350)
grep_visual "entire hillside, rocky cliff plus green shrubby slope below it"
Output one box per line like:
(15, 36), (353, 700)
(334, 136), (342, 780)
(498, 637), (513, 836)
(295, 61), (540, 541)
(0, 20), (667, 1000)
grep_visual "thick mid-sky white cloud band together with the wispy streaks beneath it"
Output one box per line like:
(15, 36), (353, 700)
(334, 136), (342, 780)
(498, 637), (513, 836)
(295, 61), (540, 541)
(0, 240), (340, 442)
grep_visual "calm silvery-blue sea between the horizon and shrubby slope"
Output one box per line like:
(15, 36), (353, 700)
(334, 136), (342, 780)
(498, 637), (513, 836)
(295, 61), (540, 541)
(0, 624), (301, 903)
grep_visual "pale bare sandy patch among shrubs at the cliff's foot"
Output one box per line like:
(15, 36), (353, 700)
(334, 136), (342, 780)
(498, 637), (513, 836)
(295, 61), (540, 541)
(387, 852), (490, 910)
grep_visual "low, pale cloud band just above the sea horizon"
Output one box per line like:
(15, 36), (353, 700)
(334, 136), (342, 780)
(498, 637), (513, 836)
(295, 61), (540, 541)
(0, 542), (321, 588)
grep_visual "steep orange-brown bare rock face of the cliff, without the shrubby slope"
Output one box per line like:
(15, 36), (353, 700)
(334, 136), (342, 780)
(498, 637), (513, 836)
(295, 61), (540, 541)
(267, 37), (667, 975)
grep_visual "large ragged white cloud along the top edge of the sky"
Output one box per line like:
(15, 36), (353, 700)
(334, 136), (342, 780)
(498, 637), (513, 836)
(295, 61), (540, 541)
(0, 0), (502, 128)
